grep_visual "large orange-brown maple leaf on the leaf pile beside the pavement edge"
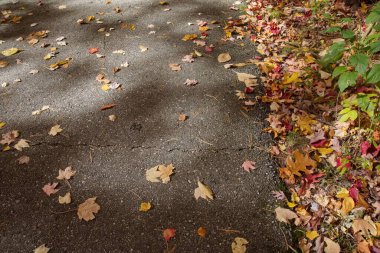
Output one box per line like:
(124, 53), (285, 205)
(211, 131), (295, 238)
(286, 150), (317, 177)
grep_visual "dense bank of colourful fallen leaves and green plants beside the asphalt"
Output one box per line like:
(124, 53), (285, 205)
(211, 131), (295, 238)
(224, 0), (380, 252)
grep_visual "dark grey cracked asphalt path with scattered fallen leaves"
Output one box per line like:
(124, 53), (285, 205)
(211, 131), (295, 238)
(0, 0), (285, 253)
